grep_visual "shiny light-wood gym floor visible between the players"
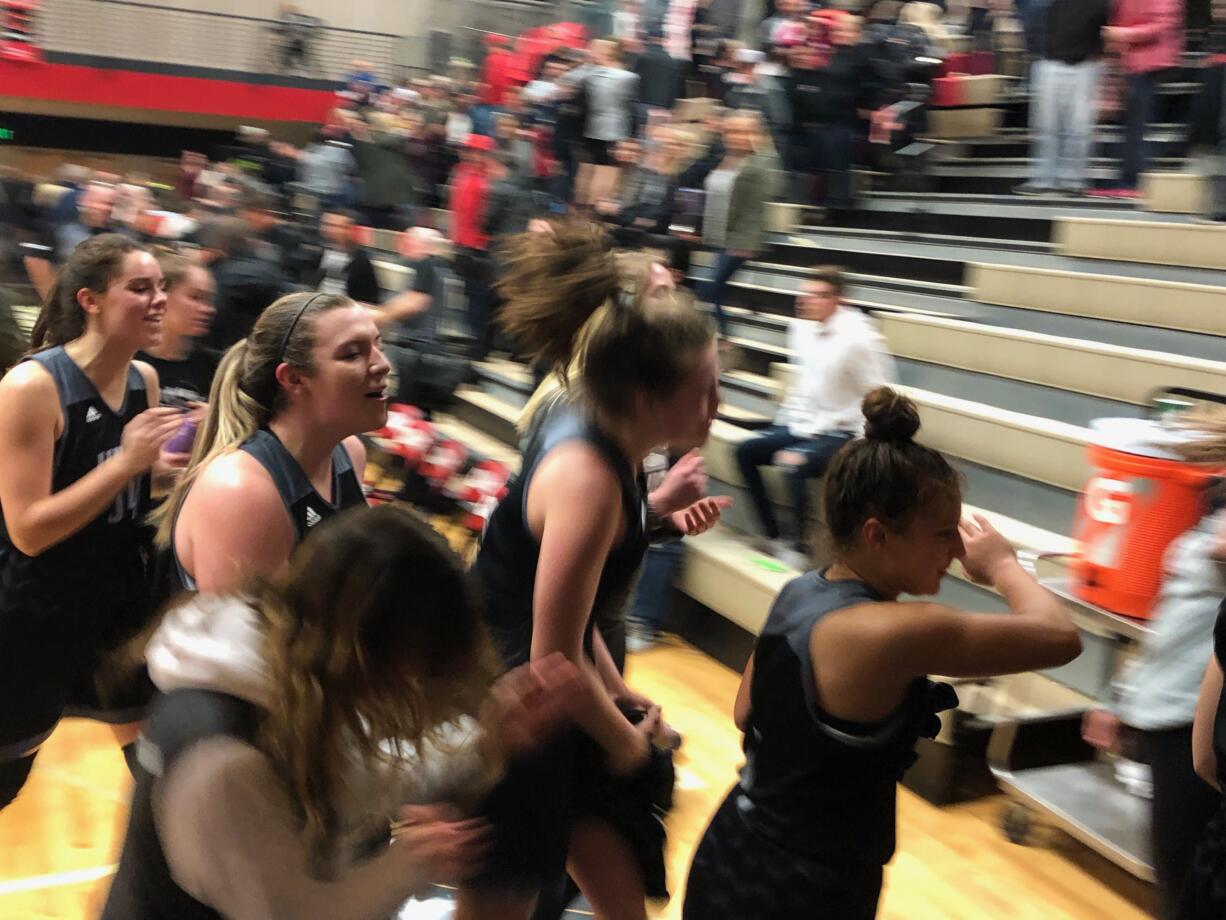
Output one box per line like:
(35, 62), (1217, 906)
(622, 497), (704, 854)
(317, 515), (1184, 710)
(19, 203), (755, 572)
(0, 642), (1151, 920)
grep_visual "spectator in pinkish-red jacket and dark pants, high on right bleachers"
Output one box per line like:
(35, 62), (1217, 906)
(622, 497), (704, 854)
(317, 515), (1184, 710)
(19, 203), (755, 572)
(1096, 0), (1183, 197)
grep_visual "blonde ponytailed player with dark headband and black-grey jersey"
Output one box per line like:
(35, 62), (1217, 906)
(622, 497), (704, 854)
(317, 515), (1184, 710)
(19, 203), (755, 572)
(158, 293), (389, 594)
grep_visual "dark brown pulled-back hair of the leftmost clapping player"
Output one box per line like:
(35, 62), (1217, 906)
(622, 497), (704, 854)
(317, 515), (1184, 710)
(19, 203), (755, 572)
(29, 233), (145, 352)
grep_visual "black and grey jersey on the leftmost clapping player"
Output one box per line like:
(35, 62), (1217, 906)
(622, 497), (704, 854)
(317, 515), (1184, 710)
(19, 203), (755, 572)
(0, 346), (150, 592)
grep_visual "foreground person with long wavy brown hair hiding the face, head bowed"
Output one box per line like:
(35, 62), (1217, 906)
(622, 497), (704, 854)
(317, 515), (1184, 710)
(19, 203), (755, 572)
(102, 505), (584, 920)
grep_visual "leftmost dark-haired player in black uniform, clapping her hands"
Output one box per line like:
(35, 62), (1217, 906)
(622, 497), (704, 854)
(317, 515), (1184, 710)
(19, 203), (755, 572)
(0, 234), (180, 807)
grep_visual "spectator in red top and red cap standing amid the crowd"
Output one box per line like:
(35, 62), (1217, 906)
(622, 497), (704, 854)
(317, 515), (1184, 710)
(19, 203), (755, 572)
(450, 134), (495, 361)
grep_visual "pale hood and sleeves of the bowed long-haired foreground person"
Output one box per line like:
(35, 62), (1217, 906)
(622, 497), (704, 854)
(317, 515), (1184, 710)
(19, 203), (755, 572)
(141, 595), (493, 920)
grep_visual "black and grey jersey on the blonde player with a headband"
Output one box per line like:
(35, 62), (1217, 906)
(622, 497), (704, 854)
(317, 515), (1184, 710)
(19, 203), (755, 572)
(170, 428), (367, 591)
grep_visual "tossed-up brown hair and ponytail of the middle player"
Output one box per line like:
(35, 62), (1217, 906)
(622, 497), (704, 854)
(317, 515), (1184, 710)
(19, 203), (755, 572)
(500, 221), (715, 418)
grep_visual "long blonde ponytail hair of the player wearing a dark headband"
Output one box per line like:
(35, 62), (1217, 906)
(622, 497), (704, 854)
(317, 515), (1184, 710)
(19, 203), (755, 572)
(150, 293), (353, 546)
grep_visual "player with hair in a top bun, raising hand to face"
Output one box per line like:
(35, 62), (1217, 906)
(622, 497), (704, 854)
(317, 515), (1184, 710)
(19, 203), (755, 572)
(684, 388), (1081, 920)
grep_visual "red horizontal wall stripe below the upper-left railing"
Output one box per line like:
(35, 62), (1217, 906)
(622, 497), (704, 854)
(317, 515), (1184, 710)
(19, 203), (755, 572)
(0, 60), (336, 123)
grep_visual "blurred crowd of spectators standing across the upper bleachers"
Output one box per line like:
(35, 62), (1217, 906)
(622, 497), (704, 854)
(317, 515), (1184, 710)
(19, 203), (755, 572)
(5, 0), (1226, 382)
